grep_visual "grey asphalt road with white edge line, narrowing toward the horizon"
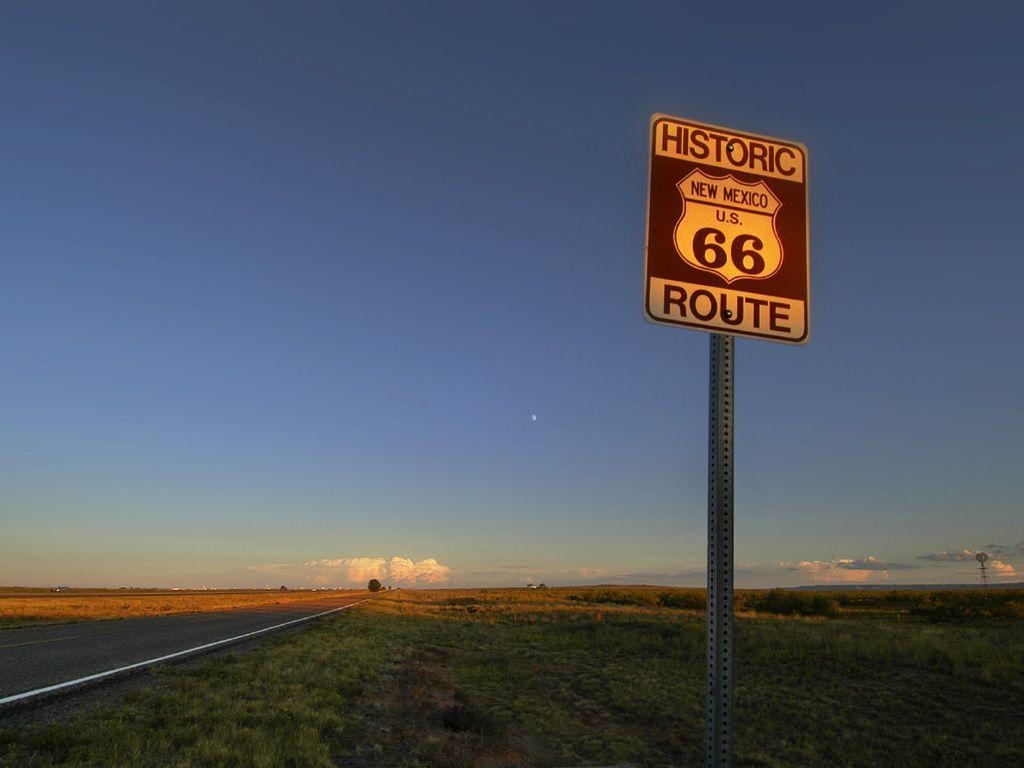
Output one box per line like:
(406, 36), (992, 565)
(0, 597), (362, 703)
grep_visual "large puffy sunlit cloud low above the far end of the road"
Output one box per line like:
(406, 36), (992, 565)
(249, 555), (452, 587)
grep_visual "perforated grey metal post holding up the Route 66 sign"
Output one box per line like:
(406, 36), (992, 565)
(708, 334), (733, 768)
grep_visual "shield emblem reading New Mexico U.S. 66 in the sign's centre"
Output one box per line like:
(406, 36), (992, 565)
(673, 170), (782, 283)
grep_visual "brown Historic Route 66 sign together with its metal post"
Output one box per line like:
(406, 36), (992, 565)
(643, 115), (811, 768)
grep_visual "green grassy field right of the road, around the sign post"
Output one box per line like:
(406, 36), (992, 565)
(0, 588), (1024, 768)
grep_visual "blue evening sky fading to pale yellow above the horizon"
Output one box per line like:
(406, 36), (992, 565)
(0, 2), (1024, 586)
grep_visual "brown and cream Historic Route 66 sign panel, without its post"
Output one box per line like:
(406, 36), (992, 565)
(644, 115), (810, 344)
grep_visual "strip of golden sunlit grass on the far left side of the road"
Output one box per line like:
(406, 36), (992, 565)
(0, 590), (367, 628)
